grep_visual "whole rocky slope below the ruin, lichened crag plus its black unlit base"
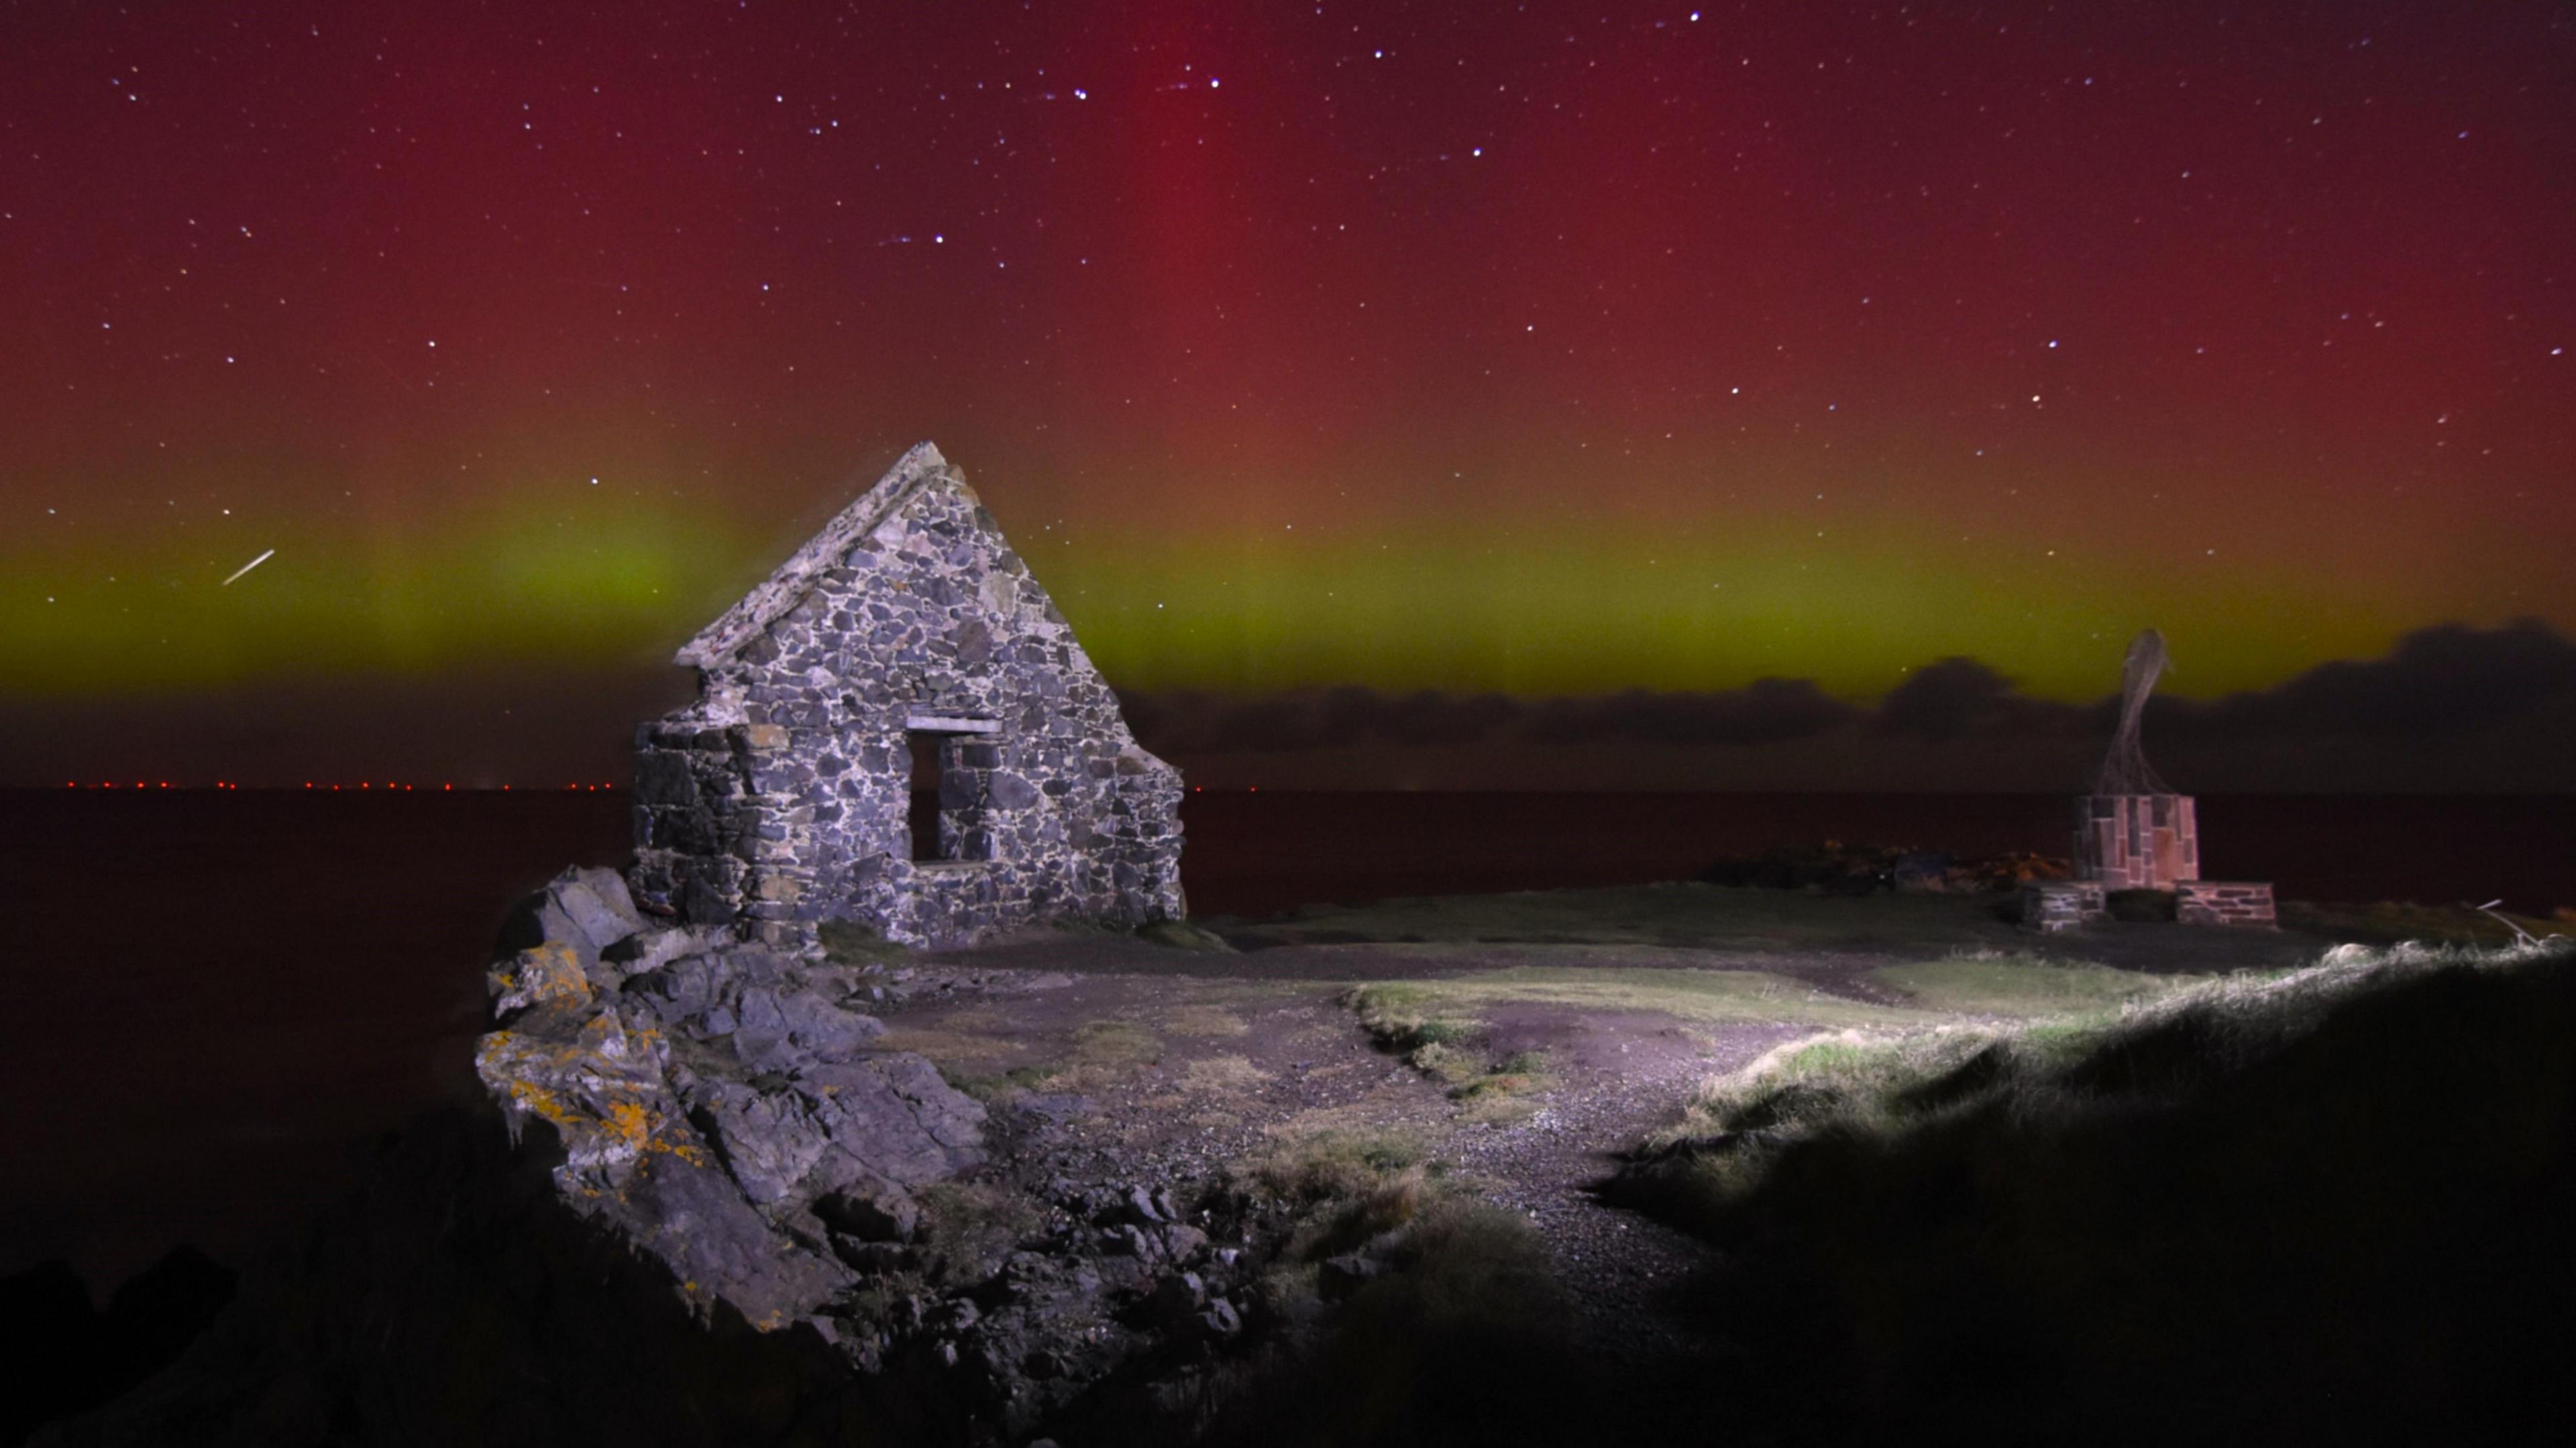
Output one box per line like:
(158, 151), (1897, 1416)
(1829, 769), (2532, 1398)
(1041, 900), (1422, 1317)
(39, 871), (1329, 1448)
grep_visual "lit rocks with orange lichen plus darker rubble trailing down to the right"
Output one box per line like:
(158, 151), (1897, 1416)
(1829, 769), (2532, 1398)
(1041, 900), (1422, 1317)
(476, 871), (1319, 1440)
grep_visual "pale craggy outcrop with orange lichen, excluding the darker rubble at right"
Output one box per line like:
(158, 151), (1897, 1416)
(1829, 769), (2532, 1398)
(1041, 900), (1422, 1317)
(474, 871), (984, 1329)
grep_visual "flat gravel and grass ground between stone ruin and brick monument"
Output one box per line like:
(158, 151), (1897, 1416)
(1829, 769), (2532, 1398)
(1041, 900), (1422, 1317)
(855, 887), (2328, 1355)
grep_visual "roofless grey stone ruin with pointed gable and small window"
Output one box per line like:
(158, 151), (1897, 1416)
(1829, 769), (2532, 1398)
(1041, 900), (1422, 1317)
(631, 443), (1185, 948)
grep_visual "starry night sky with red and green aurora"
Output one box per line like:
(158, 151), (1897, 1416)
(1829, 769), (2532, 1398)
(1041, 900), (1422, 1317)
(0, 0), (2576, 783)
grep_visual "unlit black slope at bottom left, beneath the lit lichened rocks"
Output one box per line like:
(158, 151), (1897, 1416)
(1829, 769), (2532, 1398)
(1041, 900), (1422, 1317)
(36, 1111), (966, 1448)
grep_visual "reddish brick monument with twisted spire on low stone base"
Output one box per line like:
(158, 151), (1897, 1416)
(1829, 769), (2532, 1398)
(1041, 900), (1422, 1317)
(2022, 628), (2275, 930)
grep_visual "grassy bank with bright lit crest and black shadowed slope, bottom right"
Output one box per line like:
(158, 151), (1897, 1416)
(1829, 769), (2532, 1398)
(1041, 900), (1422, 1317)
(1610, 940), (2576, 1443)
